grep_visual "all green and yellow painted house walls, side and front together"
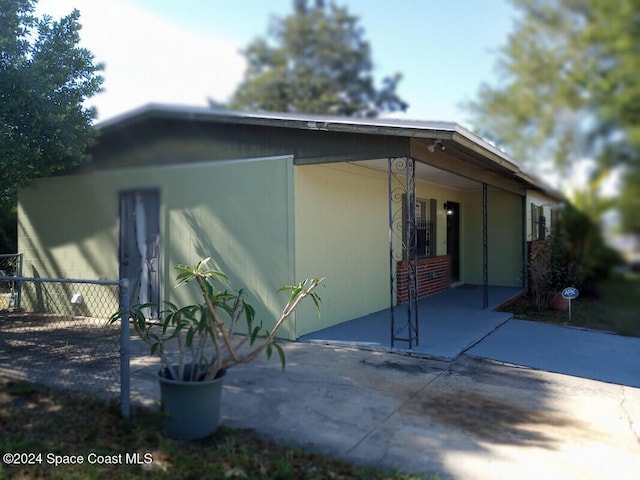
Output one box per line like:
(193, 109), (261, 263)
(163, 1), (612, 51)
(19, 152), (523, 338)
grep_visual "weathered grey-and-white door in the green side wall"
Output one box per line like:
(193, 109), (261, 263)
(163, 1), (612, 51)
(119, 190), (160, 318)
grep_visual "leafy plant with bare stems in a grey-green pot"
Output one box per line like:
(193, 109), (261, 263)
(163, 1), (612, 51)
(109, 258), (323, 381)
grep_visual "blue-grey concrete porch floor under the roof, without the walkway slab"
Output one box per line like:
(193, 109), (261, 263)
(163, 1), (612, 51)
(300, 285), (523, 359)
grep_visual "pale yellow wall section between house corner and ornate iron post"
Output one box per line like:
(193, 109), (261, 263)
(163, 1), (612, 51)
(294, 164), (389, 335)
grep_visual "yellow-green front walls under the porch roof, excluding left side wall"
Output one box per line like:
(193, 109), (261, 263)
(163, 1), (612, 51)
(294, 164), (523, 335)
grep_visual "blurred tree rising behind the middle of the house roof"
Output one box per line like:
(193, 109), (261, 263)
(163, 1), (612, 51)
(228, 0), (408, 117)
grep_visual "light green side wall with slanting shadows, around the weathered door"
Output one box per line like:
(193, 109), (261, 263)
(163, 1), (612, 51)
(19, 157), (294, 337)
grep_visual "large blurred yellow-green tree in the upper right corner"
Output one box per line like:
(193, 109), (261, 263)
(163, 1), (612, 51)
(468, 0), (640, 234)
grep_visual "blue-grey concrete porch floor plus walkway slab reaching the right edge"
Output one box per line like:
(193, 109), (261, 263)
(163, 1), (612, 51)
(300, 286), (640, 388)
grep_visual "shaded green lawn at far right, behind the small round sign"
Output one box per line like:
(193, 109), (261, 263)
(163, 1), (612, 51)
(504, 274), (640, 337)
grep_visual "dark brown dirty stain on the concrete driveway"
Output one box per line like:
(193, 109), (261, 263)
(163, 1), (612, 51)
(402, 388), (578, 448)
